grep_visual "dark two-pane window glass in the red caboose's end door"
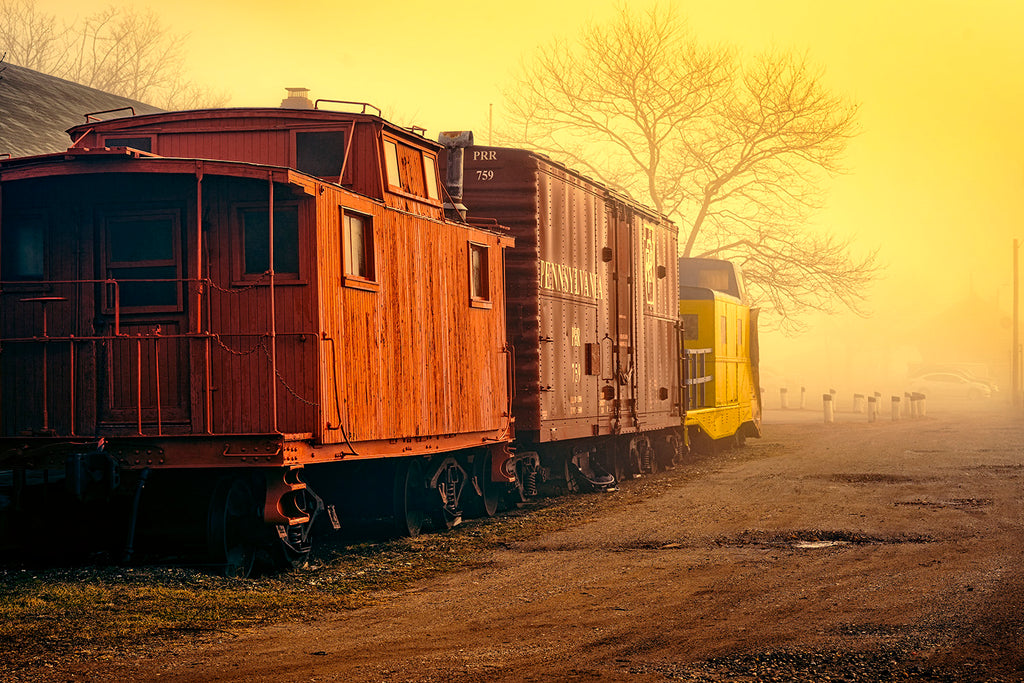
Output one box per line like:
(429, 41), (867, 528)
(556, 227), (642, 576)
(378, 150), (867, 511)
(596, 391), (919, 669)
(104, 212), (181, 310)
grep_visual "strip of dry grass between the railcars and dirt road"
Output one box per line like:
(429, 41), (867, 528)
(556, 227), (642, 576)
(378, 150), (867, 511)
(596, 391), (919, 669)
(0, 454), (720, 680)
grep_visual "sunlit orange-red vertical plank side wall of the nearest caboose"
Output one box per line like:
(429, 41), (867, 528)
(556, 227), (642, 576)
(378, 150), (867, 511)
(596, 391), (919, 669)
(317, 188), (508, 446)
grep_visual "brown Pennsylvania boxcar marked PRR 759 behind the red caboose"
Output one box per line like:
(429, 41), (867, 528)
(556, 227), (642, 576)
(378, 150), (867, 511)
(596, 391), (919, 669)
(441, 141), (685, 487)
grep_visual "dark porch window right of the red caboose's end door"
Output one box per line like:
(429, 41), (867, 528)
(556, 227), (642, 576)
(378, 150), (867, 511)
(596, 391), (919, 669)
(242, 206), (299, 279)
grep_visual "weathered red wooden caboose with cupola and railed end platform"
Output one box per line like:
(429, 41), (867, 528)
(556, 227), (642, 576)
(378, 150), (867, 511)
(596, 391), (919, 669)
(0, 102), (512, 571)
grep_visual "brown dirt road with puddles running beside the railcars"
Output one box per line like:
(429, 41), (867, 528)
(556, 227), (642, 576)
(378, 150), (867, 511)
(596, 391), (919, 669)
(68, 414), (1024, 682)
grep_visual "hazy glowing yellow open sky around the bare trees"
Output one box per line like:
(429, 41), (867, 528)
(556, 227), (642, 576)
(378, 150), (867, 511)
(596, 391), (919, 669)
(40, 0), (1024, 387)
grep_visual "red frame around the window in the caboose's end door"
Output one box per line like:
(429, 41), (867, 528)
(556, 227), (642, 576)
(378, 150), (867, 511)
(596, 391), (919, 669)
(99, 207), (185, 315)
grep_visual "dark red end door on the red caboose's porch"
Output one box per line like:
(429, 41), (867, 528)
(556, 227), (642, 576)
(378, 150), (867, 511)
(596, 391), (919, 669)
(96, 209), (188, 433)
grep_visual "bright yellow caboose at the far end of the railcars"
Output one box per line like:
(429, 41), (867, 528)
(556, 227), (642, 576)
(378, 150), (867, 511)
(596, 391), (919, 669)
(679, 258), (761, 450)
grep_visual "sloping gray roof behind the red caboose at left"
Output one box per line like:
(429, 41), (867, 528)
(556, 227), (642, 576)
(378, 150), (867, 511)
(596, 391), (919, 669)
(0, 63), (163, 157)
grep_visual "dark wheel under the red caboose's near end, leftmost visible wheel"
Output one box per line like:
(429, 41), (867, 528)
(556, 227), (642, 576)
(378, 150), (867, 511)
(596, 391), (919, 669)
(207, 477), (262, 579)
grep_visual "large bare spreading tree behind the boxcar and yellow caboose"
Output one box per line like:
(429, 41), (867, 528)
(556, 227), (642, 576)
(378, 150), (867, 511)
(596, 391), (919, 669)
(501, 7), (879, 330)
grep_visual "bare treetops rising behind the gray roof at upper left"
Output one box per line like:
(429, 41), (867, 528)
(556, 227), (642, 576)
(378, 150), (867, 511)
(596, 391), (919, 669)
(0, 0), (228, 109)
